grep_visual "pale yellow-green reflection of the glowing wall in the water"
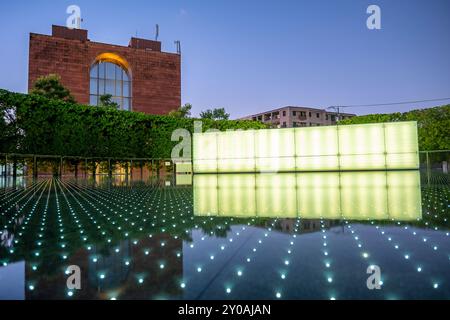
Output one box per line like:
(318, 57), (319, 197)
(194, 171), (422, 221)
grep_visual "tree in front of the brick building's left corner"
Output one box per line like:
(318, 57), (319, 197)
(30, 74), (76, 103)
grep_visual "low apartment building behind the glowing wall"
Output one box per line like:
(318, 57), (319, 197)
(242, 106), (356, 128)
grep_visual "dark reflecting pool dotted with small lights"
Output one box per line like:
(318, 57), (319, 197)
(0, 171), (450, 299)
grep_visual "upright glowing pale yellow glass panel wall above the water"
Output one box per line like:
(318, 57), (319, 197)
(193, 122), (419, 173)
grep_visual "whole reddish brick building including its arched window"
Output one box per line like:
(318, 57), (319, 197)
(28, 26), (181, 114)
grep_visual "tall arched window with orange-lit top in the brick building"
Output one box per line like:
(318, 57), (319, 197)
(90, 54), (132, 111)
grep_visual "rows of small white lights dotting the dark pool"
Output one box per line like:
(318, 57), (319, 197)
(2, 180), (450, 299)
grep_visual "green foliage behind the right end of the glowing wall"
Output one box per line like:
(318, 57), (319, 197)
(339, 105), (450, 151)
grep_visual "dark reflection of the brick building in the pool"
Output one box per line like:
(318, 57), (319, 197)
(26, 234), (183, 300)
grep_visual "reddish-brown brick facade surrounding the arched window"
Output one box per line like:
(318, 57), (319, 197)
(28, 26), (181, 114)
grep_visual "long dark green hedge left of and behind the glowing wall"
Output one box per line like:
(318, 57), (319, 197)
(0, 90), (266, 158)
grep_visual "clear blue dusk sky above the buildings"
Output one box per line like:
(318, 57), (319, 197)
(0, 0), (450, 118)
